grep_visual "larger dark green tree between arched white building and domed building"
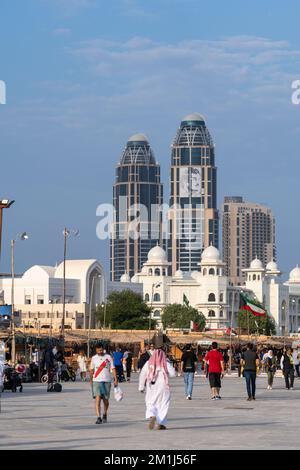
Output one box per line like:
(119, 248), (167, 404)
(96, 290), (156, 330)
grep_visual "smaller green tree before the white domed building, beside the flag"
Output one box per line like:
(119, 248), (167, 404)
(161, 304), (206, 331)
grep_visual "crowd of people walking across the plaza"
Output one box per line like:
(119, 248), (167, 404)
(1, 336), (300, 430)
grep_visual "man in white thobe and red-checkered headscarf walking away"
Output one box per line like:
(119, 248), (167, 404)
(139, 349), (176, 430)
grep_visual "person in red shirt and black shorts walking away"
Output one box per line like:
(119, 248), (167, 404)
(205, 341), (224, 400)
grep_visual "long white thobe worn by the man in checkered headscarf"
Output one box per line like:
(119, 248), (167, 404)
(139, 362), (176, 426)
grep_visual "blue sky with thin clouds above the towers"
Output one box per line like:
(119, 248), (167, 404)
(0, 0), (300, 278)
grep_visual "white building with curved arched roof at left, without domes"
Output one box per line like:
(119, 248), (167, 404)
(0, 260), (107, 329)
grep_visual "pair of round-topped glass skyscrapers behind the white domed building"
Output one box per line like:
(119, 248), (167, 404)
(110, 113), (219, 281)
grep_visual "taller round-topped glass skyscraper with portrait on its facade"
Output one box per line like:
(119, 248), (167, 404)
(168, 113), (219, 274)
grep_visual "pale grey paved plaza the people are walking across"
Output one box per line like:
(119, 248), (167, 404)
(0, 374), (300, 450)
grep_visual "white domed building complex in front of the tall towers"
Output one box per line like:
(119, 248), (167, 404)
(120, 242), (300, 335)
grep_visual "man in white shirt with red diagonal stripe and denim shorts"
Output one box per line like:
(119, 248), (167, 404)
(90, 343), (118, 424)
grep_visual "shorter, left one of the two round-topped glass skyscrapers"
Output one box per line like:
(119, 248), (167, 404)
(110, 134), (163, 281)
